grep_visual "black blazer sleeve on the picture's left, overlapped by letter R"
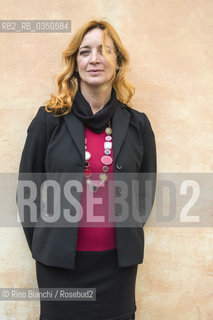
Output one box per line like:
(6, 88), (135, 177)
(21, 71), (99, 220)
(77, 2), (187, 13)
(16, 107), (47, 252)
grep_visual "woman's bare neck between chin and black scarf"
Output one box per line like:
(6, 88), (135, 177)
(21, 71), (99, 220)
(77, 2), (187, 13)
(80, 83), (112, 114)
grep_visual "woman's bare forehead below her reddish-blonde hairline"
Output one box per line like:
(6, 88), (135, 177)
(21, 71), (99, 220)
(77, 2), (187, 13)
(80, 28), (114, 47)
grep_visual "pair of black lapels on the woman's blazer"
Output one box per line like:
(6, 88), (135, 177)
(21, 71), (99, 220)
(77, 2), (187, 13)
(64, 102), (130, 163)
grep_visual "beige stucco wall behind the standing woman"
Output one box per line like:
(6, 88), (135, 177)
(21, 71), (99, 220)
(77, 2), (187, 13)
(0, 0), (213, 320)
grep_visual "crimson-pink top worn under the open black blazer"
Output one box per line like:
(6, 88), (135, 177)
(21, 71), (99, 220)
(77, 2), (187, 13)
(77, 127), (116, 251)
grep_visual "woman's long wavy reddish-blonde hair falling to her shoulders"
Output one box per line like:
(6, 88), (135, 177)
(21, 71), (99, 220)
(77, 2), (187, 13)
(44, 20), (135, 116)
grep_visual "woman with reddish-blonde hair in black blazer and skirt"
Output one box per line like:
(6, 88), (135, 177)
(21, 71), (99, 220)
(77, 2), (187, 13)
(19, 21), (156, 320)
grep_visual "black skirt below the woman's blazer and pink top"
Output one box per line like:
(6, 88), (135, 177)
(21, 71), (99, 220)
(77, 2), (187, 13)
(36, 249), (138, 320)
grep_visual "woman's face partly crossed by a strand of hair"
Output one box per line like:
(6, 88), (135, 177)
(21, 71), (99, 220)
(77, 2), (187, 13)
(77, 28), (117, 87)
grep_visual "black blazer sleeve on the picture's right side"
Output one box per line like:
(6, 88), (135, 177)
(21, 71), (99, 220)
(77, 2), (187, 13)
(139, 113), (157, 226)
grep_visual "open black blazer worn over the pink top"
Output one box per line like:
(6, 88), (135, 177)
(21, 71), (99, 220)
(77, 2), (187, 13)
(19, 102), (156, 269)
